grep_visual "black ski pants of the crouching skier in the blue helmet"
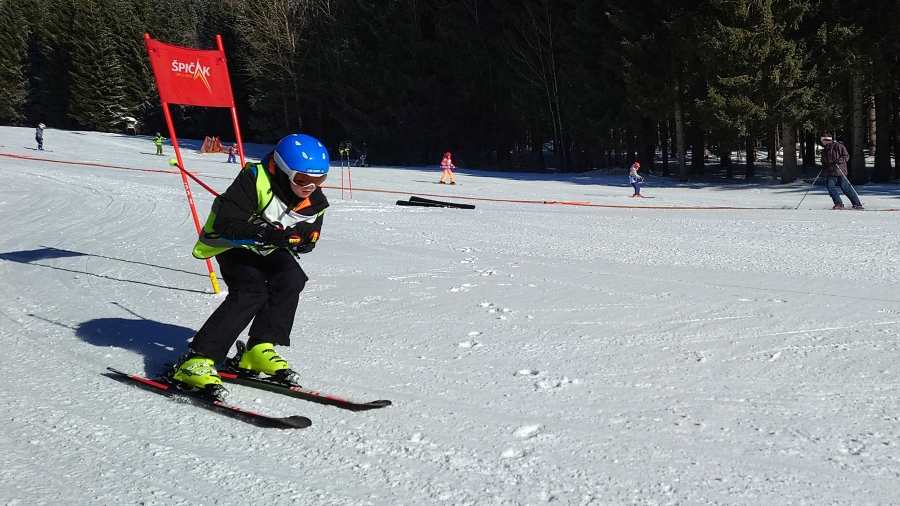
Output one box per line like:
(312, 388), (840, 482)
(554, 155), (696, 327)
(190, 248), (309, 363)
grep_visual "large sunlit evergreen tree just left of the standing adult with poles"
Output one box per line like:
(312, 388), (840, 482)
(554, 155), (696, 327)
(702, 0), (816, 183)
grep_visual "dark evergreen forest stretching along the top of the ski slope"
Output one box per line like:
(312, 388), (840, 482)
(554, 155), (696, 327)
(0, 0), (900, 184)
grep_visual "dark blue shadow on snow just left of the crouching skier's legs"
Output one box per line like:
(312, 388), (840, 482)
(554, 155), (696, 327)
(75, 318), (195, 374)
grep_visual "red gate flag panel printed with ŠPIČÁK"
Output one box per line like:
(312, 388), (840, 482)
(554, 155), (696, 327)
(144, 35), (234, 108)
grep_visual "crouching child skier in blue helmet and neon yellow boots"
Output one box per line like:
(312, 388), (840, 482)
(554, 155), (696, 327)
(170, 134), (329, 399)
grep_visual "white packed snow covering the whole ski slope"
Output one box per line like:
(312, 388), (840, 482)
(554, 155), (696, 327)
(0, 127), (900, 506)
